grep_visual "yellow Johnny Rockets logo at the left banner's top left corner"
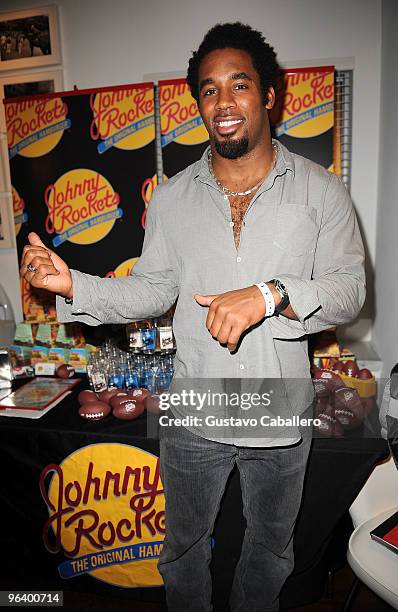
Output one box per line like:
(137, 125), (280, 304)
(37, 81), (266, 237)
(4, 97), (71, 159)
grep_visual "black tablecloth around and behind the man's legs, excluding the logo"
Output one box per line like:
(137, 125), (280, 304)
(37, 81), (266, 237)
(0, 382), (389, 607)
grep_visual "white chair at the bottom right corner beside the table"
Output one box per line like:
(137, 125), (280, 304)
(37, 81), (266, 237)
(344, 456), (398, 612)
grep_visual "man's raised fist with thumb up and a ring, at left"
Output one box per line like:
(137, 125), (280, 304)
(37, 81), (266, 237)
(20, 232), (73, 298)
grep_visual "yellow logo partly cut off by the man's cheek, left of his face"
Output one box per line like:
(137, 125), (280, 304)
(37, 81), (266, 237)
(159, 79), (209, 147)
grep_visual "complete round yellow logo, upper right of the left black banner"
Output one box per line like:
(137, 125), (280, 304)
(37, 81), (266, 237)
(90, 84), (155, 153)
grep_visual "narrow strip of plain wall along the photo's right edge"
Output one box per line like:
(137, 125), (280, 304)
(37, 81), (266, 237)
(373, 0), (398, 375)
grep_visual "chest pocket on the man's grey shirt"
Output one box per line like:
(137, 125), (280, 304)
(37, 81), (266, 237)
(273, 204), (319, 257)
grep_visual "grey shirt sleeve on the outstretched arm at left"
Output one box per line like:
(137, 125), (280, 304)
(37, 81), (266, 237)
(56, 188), (178, 325)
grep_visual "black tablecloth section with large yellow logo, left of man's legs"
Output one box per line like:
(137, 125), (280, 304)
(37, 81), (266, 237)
(0, 408), (165, 592)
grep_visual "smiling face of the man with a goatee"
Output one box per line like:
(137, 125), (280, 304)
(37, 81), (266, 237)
(199, 48), (275, 159)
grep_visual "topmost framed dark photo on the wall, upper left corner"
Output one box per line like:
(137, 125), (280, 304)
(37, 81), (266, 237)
(0, 6), (61, 72)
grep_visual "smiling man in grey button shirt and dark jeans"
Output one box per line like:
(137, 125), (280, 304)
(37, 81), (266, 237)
(21, 23), (365, 612)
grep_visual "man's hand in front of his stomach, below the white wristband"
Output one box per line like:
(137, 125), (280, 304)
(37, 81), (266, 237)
(194, 285), (265, 352)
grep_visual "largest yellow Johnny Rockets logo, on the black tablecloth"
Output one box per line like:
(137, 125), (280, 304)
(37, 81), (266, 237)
(40, 444), (165, 587)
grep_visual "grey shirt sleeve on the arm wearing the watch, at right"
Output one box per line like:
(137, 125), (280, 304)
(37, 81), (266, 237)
(269, 175), (366, 339)
